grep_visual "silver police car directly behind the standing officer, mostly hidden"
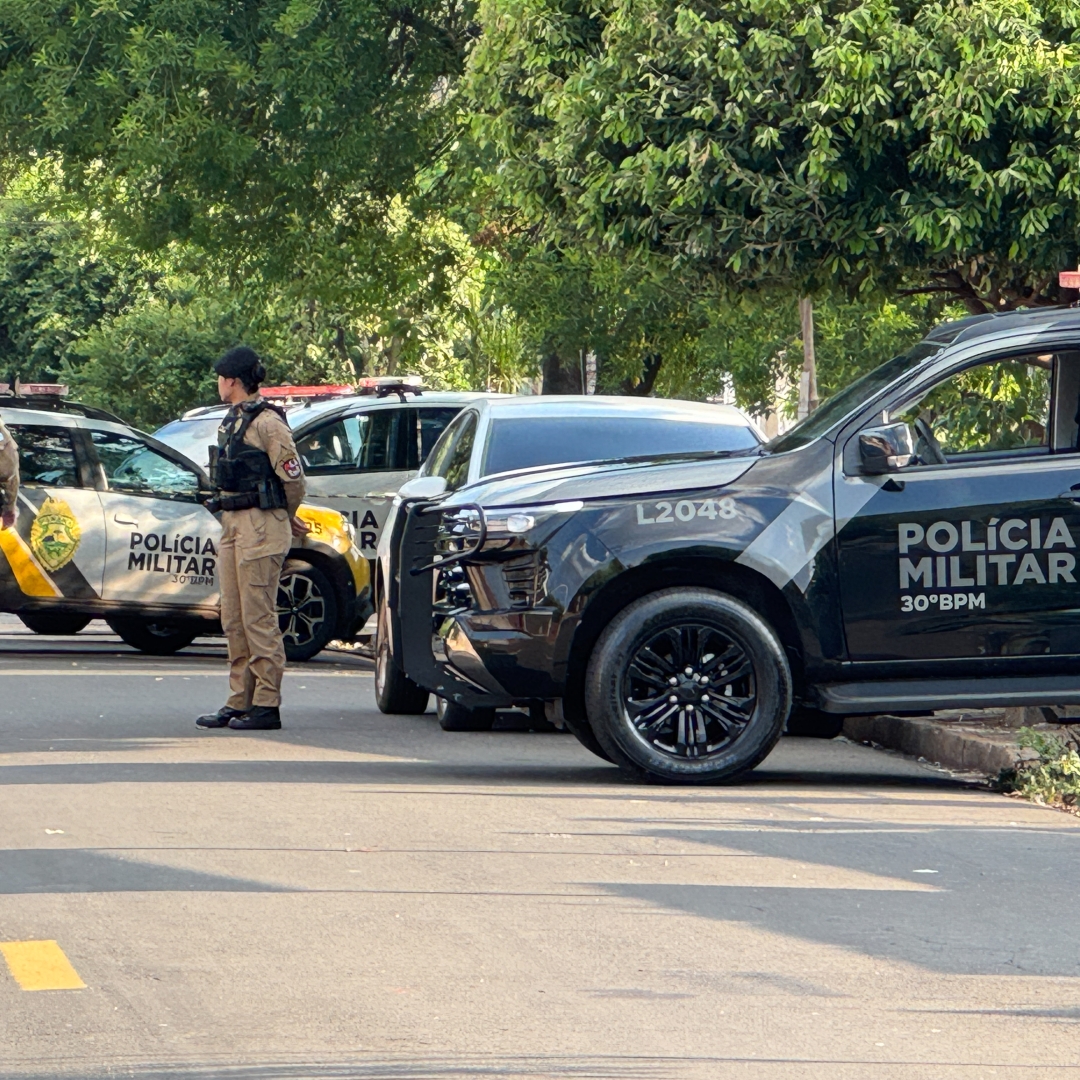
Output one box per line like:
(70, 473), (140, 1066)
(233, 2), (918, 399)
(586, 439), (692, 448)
(154, 376), (491, 558)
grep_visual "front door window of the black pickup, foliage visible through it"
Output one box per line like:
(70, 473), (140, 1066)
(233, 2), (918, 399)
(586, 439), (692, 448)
(895, 354), (1054, 462)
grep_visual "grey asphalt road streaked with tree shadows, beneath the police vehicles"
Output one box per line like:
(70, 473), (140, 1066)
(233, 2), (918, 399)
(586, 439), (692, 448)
(0, 618), (1080, 1080)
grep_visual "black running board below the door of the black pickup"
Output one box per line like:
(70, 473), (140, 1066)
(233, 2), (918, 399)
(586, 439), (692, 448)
(818, 675), (1080, 716)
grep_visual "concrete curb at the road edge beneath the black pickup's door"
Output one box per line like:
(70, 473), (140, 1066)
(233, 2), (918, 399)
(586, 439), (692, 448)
(843, 716), (1028, 777)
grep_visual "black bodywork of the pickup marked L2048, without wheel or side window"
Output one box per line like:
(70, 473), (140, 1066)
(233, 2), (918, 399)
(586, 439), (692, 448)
(389, 309), (1080, 712)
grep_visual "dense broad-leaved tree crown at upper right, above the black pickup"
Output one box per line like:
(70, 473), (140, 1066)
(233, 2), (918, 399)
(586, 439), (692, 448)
(467, 0), (1080, 311)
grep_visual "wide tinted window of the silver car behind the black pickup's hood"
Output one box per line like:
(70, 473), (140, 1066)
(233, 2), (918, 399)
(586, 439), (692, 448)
(482, 416), (758, 476)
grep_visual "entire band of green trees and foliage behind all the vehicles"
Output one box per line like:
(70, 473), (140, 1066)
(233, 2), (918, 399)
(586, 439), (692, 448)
(0, 0), (1080, 428)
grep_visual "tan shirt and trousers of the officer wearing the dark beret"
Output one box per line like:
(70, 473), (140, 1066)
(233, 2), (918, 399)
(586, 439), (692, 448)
(218, 397), (305, 710)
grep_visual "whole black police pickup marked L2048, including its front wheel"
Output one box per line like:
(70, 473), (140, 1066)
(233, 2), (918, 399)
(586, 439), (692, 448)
(377, 308), (1080, 783)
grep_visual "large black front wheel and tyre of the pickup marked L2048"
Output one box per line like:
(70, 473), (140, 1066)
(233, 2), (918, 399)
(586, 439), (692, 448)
(585, 589), (792, 783)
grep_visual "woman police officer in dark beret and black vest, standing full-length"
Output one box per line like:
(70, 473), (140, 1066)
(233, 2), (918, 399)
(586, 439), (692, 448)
(195, 346), (308, 730)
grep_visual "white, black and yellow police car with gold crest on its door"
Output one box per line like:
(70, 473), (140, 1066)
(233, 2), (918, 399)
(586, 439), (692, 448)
(0, 386), (372, 660)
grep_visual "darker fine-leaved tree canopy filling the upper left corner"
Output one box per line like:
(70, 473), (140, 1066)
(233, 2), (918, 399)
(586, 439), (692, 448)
(0, 0), (468, 302)
